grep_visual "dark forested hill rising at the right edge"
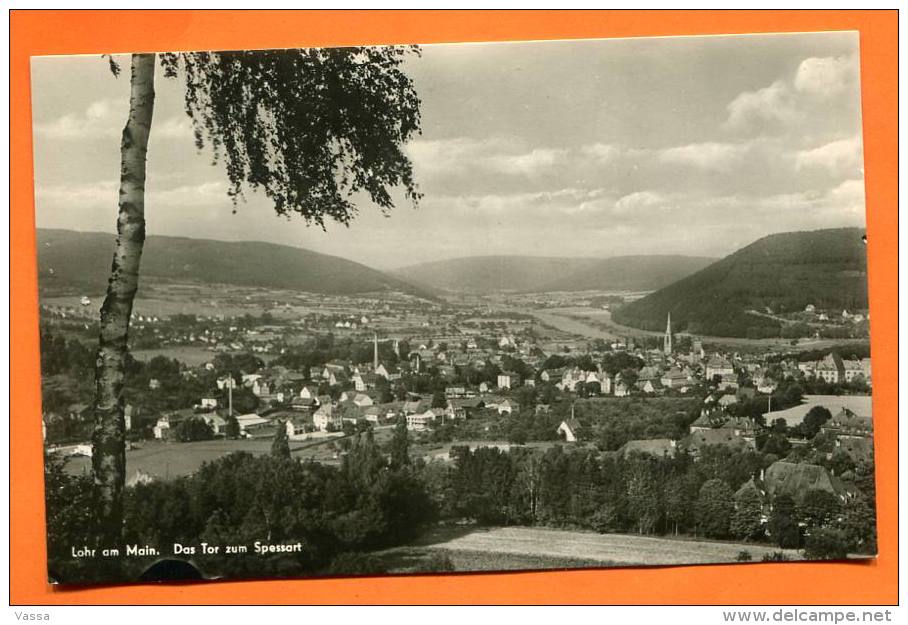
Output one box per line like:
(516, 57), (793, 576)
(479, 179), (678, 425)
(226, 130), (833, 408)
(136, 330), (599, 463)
(613, 228), (867, 337)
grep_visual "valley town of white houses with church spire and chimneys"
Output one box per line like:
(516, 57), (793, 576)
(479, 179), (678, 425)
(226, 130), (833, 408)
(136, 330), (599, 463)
(42, 282), (873, 572)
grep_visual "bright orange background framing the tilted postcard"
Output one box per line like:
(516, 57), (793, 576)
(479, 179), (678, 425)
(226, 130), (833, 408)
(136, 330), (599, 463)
(9, 10), (898, 604)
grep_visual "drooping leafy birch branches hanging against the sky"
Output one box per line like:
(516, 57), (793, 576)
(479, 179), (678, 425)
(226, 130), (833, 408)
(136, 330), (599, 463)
(161, 46), (420, 227)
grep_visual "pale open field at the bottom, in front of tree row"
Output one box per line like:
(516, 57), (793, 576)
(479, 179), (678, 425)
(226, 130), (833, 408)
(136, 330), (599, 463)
(390, 527), (799, 571)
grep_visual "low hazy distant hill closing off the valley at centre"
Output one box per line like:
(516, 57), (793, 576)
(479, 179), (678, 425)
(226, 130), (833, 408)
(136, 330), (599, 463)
(394, 256), (715, 293)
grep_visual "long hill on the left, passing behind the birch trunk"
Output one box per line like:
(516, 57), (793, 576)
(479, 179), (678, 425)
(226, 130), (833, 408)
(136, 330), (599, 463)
(38, 229), (431, 297)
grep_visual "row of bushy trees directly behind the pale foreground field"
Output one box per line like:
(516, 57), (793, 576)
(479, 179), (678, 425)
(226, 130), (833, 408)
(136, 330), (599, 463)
(429, 446), (876, 557)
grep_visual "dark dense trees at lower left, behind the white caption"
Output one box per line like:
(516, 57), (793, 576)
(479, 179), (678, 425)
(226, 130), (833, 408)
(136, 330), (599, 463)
(46, 427), (435, 582)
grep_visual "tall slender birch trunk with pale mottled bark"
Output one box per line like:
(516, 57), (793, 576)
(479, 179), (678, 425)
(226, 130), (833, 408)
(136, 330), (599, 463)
(91, 54), (155, 544)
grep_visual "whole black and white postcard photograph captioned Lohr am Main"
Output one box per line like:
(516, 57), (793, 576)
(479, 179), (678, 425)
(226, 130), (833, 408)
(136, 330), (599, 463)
(30, 31), (882, 585)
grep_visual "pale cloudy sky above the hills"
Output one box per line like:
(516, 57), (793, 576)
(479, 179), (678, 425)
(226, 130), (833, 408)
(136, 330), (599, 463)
(31, 32), (865, 269)
